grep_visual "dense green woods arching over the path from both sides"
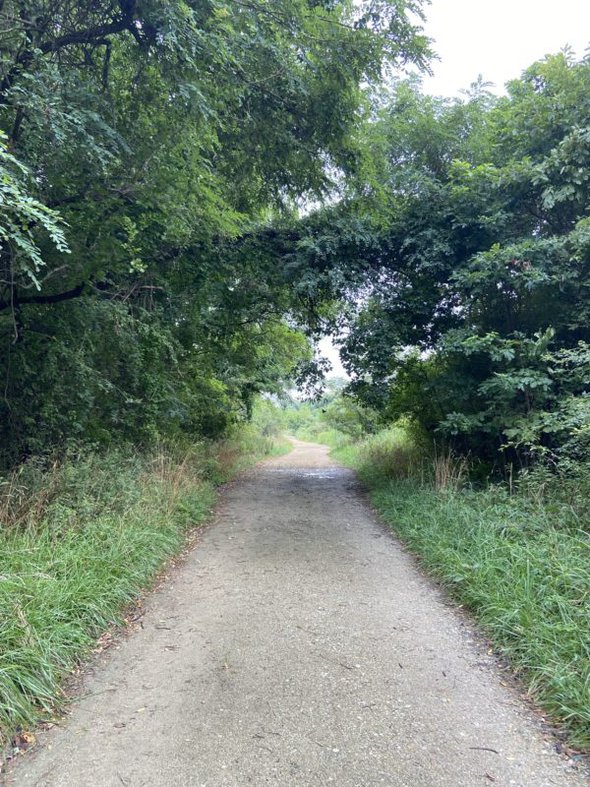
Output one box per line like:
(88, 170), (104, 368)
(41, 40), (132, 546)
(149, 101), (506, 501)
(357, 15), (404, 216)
(0, 2), (590, 478)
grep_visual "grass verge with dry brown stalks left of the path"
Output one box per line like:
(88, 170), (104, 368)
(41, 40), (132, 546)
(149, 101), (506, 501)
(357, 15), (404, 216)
(0, 429), (290, 751)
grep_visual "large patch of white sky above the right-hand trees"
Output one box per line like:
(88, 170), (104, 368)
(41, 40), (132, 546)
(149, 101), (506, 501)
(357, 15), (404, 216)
(424, 0), (590, 96)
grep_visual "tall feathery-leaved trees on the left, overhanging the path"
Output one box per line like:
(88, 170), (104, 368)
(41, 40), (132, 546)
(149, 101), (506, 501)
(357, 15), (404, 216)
(0, 0), (426, 463)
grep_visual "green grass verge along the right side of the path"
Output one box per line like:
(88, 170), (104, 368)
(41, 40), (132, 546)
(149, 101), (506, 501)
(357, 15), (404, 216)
(335, 435), (590, 751)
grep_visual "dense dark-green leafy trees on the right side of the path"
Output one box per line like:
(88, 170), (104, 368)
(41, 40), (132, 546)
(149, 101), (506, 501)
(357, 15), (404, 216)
(300, 53), (590, 474)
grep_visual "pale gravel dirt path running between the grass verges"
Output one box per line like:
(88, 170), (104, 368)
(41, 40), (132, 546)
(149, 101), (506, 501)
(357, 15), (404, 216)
(8, 443), (588, 787)
